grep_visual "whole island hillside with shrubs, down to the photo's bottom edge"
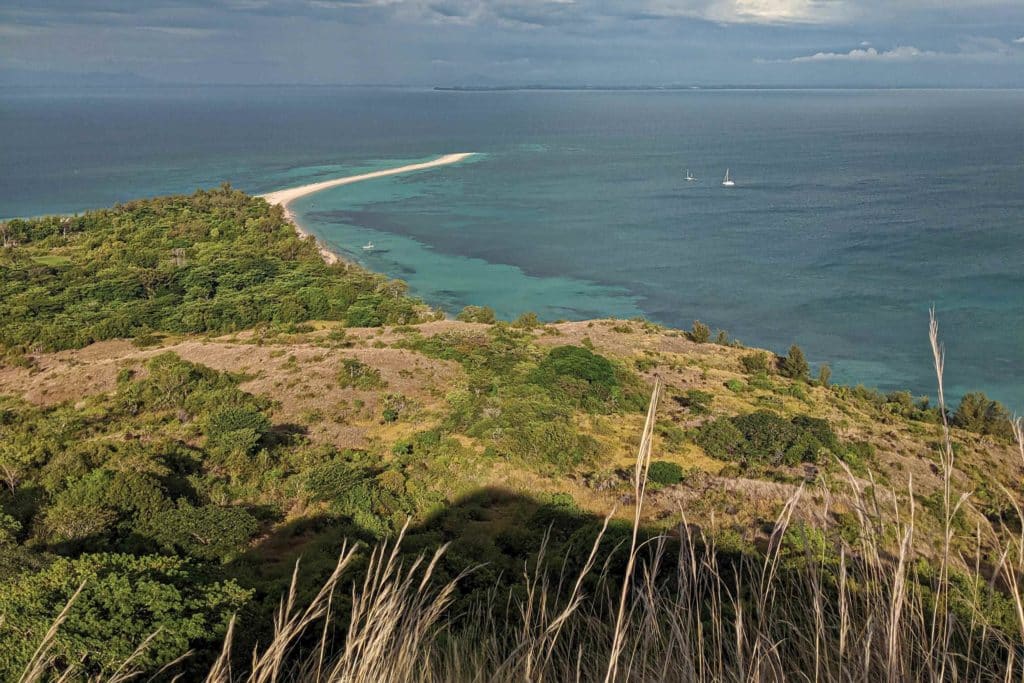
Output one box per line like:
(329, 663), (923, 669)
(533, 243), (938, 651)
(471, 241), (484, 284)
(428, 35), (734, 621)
(0, 187), (1024, 680)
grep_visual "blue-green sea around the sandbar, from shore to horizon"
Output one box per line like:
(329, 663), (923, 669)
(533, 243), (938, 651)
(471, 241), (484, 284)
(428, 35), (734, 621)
(0, 83), (1024, 411)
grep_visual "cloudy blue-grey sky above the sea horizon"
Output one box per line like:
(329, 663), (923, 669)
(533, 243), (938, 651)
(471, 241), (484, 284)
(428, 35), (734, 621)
(0, 0), (1024, 87)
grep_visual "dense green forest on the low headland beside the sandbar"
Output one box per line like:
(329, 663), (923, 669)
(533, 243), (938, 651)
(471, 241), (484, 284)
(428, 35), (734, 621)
(0, 185), (422, 350)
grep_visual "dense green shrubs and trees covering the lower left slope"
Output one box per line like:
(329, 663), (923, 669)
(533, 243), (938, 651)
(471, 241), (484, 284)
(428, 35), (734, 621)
(0, 354), (443, 679)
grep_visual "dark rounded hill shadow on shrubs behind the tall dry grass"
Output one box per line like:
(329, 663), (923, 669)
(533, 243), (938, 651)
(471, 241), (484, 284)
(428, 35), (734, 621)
(223, 487), (674, 651)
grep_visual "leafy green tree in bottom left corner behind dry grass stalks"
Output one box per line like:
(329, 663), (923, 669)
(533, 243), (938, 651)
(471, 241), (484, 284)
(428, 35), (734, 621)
(0, 554), (252, 680)
